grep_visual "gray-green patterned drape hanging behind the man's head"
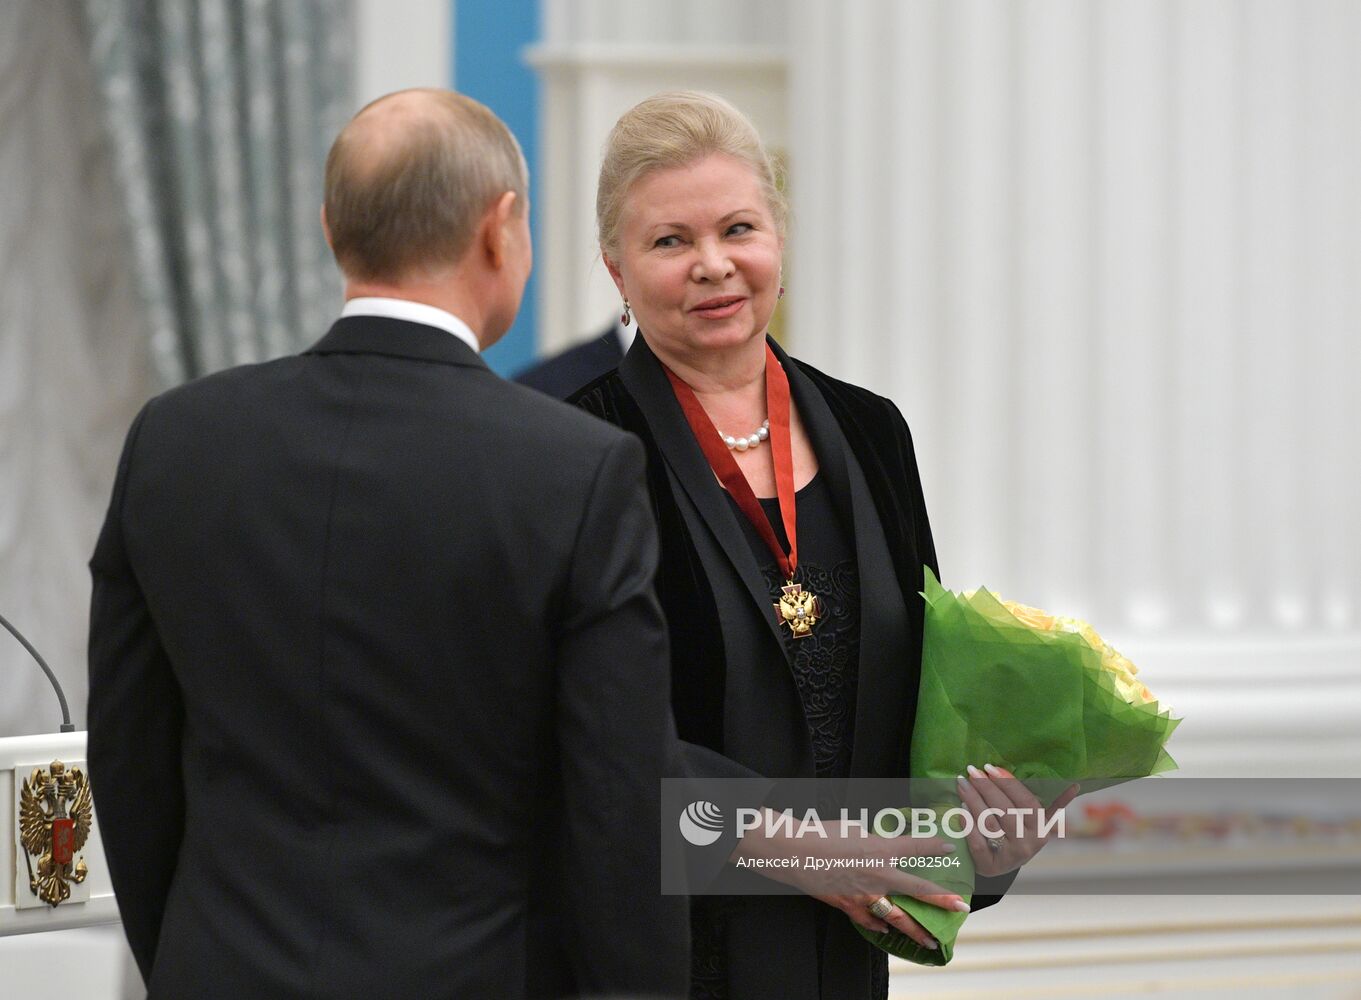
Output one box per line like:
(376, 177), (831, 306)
(82, 0), (355, 386)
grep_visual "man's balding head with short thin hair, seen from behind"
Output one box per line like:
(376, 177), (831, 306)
(325, 90), (528, 282)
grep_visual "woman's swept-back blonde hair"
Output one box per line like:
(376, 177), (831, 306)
(596, 90), (789, 257)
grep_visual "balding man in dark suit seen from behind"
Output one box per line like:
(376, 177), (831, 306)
(88, 91), (689, 997)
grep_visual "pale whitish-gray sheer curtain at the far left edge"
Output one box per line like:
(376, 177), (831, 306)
(0, 0), (154, 740)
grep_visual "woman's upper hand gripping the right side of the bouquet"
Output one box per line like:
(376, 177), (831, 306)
(958, 763), (1078, 875)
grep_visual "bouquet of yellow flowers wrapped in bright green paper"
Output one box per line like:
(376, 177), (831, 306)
(857, 569), (1180, 965)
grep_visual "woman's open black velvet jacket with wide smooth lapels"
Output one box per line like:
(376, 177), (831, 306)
(572, 336), (1010, 1000)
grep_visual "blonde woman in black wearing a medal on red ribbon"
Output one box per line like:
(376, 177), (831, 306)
(573, 93), (1038, 1000)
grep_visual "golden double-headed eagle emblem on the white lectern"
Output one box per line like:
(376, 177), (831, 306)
(19, 761), (94, 906)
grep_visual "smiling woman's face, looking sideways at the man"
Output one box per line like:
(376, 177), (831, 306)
(604, 154), (784, 356)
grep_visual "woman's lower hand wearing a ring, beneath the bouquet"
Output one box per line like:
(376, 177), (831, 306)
(734, 823), (969, 948)
